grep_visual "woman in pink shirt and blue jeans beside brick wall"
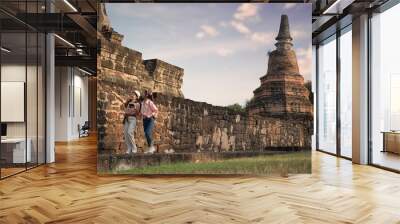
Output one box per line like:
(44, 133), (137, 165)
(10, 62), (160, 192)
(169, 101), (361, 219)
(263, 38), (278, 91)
(140, 91), (158, 153)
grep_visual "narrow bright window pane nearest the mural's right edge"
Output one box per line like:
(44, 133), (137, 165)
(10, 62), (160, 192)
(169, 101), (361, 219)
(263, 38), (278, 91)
(318, 37), (336, 153)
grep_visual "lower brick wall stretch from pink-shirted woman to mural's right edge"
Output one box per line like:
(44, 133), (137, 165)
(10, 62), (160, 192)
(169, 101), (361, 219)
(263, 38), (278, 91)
(155, 96), (311, 151)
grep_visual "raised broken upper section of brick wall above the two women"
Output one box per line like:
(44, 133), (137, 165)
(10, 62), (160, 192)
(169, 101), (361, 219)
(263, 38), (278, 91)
(97, 28), (183, 97)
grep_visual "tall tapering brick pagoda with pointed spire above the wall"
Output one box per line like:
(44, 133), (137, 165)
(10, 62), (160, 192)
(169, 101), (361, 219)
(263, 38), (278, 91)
(248, 15), (312, 117)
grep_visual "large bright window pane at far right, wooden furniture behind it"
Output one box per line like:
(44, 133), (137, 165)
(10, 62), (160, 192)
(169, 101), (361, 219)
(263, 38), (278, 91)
(371, 5), (400, 170)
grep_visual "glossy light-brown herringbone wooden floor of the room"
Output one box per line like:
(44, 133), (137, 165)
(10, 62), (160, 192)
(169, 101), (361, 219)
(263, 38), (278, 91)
(0, 138), (400, 224)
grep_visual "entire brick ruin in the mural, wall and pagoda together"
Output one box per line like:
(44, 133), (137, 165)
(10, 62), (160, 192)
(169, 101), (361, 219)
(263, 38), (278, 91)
(97, 13), (313, 153)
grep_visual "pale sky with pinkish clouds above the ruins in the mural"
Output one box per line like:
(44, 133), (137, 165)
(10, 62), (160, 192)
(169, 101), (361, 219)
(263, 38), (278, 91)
(106, 3), (312, 106)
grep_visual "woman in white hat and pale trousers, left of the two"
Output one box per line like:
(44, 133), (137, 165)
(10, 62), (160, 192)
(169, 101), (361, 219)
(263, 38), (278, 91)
(123, 90), (140, 154)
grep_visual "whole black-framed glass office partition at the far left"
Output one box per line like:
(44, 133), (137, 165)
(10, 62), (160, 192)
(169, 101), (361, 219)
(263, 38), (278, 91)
(0, 1), (46, 178)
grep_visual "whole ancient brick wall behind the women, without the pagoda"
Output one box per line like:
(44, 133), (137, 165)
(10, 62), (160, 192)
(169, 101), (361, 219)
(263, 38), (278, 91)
(97, 32), (312, 153)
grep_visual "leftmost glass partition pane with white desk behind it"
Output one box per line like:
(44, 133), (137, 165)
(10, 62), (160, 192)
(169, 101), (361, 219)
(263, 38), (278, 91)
(0, 32), (30, 177)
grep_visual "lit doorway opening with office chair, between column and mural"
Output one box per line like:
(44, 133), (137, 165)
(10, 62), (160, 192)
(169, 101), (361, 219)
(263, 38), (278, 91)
(55, 66), (96, 144)
